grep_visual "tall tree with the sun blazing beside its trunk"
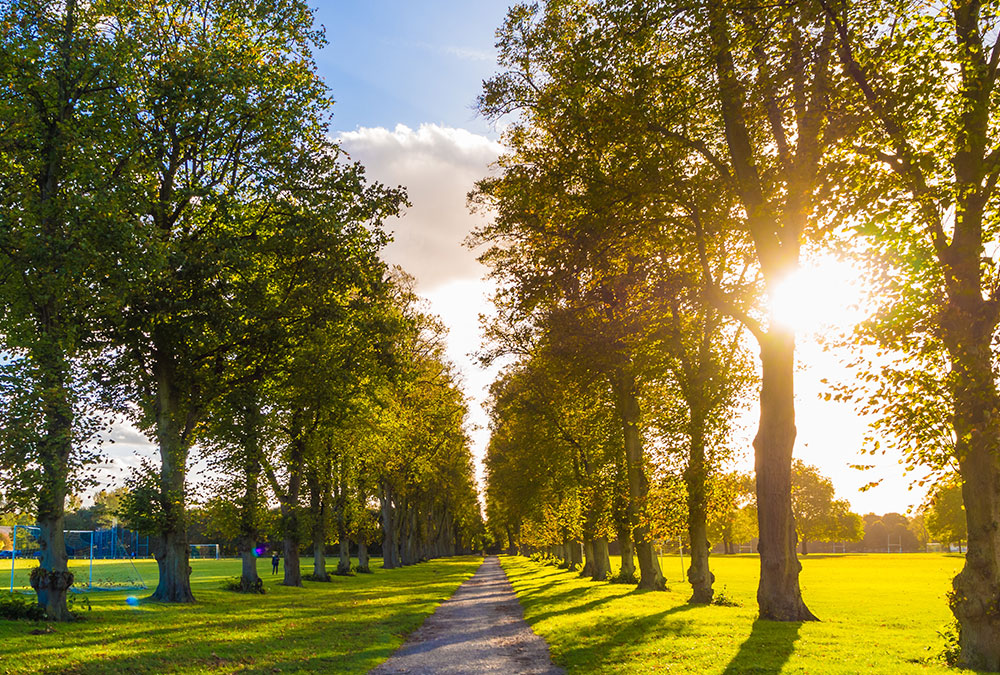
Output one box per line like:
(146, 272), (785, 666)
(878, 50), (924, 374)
(666, 2), (834, 621)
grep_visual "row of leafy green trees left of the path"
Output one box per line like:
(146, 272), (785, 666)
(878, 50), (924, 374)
(0, 0), (479, 620)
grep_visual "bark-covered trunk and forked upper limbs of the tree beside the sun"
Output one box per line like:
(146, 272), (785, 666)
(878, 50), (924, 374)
(705, 2), (820, 621)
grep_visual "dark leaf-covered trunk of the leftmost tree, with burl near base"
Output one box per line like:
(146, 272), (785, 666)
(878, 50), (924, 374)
(32, 339), (73, 621)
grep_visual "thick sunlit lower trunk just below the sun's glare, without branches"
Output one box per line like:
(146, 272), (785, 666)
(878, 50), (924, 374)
(753, 326), (816, 621)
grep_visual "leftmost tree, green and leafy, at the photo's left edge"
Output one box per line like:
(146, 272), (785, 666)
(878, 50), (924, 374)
(0, 0), (138, 621)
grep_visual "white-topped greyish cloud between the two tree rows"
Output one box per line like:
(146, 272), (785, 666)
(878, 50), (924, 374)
(339, 124), (501, 292)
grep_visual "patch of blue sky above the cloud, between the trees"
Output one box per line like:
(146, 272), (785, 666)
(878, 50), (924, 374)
(314, 0), (508, 136)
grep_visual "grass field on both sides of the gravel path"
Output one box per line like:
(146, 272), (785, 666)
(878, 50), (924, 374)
(0, 554), (969, 674)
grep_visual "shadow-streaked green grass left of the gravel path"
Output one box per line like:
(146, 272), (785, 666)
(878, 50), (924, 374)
(0, 557), (482, 675)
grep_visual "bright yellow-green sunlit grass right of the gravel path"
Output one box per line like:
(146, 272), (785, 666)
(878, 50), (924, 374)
(501, 554), (971, 674)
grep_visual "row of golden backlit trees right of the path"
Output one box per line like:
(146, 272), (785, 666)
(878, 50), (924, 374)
(472, 0), (1000, 670)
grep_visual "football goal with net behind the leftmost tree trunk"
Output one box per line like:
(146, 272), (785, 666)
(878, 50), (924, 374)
(9, 525), (147, 593)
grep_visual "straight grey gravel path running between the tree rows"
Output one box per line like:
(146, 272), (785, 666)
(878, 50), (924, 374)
(369, 556), (564, 675)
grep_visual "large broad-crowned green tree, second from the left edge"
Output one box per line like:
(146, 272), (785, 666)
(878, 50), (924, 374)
(104, 0), (401, 602)
